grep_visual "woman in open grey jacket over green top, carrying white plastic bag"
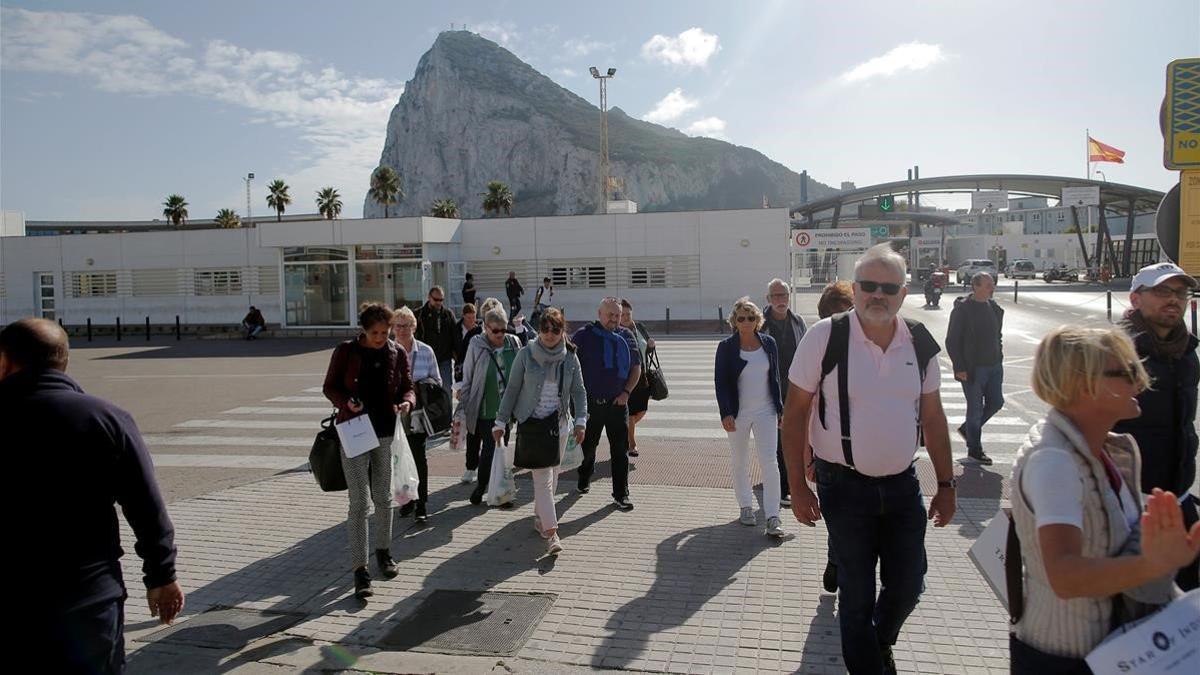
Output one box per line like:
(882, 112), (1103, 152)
(454, 307), (521, 506)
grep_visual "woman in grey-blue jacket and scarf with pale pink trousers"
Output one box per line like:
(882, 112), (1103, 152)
(492, 307), (588, 555)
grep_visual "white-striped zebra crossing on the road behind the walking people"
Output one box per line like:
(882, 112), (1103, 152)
(145, 338), (1034, 471)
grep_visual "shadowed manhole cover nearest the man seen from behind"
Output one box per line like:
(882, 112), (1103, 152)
(139, 608), (305, 650)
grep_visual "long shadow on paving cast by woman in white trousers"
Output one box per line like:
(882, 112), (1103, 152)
(592, 521), (781, 669)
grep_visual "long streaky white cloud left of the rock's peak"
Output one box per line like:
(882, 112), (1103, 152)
(0, 7), (403, 210)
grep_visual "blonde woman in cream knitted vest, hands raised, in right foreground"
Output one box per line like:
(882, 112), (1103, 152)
(1009, 325), (1200, 675)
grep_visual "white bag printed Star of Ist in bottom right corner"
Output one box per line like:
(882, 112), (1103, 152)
(1087, 589), (1200, 675)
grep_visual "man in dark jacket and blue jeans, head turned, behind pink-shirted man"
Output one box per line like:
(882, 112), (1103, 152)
(946, 271), (1004, 465)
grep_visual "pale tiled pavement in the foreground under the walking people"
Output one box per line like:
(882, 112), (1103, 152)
(122, 468), (1008, 674)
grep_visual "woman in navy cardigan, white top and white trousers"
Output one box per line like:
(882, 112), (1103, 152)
(714, 297), (785, 537)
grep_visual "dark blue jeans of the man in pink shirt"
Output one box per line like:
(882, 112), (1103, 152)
(816, 459), (926, 675)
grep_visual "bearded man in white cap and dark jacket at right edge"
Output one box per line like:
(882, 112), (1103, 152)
(1112, 263), (1200, 590)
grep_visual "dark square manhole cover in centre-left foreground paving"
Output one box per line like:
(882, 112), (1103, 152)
(379, 591), (554, 656)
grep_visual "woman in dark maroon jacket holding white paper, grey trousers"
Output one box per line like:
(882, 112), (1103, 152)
(322, 304), (416, 599)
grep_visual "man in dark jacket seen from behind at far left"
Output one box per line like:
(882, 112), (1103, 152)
(0, 318), (184, 673)
